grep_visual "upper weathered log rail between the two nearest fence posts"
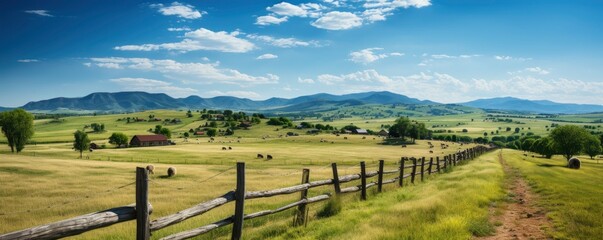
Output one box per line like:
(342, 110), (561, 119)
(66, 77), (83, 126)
(151, 191), (235, 231)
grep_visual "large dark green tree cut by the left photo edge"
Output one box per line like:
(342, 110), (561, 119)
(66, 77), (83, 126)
(0, 108), (34, 153)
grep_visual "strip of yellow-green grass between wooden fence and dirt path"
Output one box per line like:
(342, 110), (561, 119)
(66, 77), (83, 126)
(245, 152), (505, 239)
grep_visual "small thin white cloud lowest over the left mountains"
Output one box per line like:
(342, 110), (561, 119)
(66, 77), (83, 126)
(109, 78), (197, 97)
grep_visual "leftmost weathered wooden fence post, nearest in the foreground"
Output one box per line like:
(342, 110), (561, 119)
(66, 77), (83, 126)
(136, 167), (151, 240)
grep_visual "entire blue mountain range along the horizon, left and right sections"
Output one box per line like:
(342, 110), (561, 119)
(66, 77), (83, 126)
(0, 91), (603, 114)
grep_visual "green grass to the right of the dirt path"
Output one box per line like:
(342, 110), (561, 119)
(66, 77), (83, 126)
(503, 149), (603, 239)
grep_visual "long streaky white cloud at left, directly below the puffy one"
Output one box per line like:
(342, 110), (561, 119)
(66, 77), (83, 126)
(90, 57), (279, 85)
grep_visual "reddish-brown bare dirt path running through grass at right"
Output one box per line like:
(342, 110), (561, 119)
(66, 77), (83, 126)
(475, 154), (551, 240)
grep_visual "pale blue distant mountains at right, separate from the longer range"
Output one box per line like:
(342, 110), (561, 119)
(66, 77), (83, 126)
(460, 97), (603, 114)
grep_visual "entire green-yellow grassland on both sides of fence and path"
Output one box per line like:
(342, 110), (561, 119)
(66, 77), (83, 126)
(0, 109), (603, 239)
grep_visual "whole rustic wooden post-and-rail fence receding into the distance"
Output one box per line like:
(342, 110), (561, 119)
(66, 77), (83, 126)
(0, 146), (491, 240)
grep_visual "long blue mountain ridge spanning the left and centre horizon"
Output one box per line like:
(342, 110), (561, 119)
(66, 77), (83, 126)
(9, 92), (437, 112)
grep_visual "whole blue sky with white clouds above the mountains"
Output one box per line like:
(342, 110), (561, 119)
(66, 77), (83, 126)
(0, 0), (603, 106)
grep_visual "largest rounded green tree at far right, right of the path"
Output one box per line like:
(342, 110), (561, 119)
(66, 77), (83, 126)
(550, 125), (590, 161)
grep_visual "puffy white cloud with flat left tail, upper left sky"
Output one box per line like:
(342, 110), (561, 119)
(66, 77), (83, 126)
(114, 28), (255, 53)
